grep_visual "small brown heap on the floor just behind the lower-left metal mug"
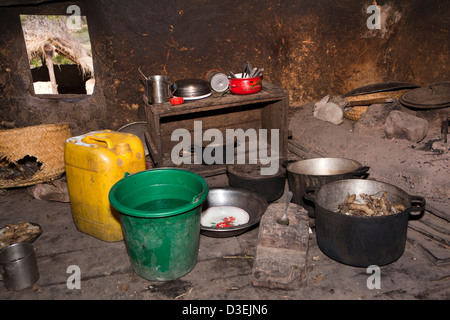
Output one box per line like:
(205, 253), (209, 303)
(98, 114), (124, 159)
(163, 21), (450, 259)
(0, 222), (41, 250)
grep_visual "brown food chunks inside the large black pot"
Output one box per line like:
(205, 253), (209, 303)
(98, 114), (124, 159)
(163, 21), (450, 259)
(336, 192), (406, 217)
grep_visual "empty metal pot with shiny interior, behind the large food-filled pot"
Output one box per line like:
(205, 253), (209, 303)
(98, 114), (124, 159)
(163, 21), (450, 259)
(286, 158), (370, 217)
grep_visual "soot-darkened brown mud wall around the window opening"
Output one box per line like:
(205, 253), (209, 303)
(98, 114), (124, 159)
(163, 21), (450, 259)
(0, 0), (450, 134)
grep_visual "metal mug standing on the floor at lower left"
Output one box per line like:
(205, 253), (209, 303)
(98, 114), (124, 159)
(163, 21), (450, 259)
(0, 243), (39, 291)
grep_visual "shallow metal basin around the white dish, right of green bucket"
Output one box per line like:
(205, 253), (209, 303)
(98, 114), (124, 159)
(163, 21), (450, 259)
(200, 188), (268, 238)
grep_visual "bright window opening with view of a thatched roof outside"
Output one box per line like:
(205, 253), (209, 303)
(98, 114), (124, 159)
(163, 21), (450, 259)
(20, 15), (95, 95)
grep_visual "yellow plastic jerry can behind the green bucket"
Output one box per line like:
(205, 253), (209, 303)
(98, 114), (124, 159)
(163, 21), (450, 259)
(64, 130), (146, 242)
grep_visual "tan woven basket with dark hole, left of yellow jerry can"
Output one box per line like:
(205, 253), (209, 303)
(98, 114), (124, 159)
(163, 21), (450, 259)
(0, 124), (71, 189)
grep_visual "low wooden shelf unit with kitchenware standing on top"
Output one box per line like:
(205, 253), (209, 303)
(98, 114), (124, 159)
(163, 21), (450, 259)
(143, 81), (289, 173)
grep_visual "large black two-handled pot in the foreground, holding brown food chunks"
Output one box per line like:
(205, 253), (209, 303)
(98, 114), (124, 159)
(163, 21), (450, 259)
(305, 179), (425, 267)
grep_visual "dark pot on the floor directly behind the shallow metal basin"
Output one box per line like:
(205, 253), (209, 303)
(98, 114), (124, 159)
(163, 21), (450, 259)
(227, 165), (286, 202)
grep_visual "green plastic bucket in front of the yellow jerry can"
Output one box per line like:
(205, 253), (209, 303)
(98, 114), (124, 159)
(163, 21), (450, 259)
(109, 168), (209, 281)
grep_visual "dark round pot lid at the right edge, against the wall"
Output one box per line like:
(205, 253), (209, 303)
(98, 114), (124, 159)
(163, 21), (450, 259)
(400, 81), (450, 109)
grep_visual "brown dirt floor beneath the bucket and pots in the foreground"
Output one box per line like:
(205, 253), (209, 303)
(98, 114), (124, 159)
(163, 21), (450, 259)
(0, 174), (450, 301)
